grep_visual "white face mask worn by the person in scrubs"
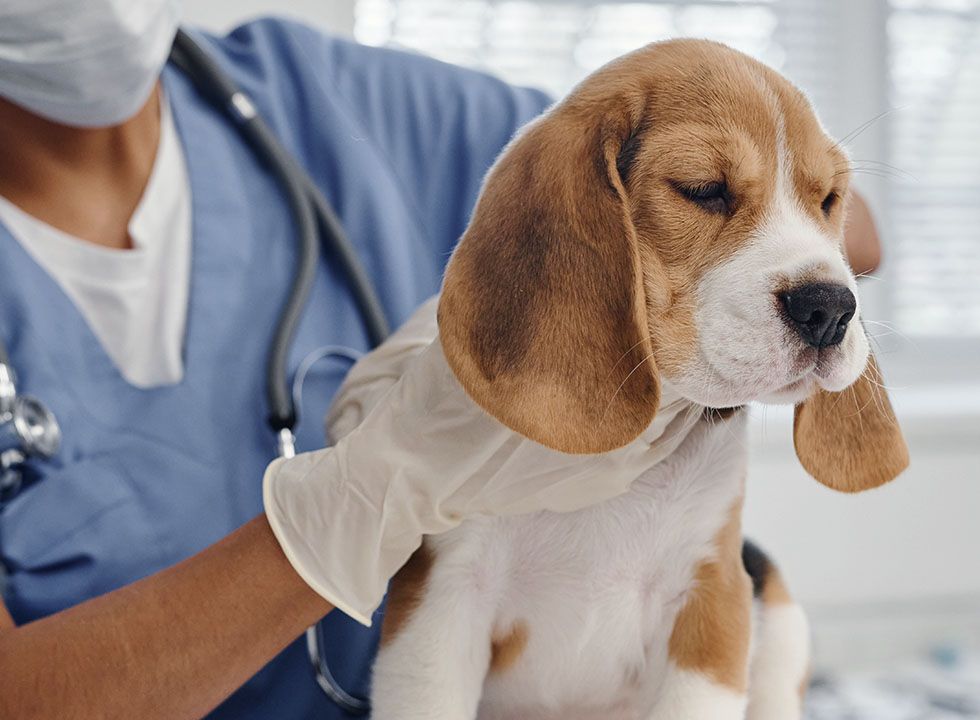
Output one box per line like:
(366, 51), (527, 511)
(0, 0), (179, 127)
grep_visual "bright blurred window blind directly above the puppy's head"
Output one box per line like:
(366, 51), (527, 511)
(355, 0), (826, 112)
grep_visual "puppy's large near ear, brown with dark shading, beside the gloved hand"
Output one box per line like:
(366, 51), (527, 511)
(439, 104), (660, 453)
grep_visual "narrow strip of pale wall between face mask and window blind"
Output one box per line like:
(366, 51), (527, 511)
(183, 0), (354, 35)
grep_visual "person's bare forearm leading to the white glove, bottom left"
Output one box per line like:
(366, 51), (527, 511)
(0, 517), (331, 720)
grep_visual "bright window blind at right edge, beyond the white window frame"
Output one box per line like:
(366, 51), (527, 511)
(888, 0), (980, 338)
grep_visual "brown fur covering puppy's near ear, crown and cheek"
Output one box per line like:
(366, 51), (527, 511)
(439, 40), (839, 453)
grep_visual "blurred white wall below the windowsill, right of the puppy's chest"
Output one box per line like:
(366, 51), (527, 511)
(745, 394), (980, 667)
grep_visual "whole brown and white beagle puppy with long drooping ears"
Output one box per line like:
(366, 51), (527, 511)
(364, 40), (908, 720)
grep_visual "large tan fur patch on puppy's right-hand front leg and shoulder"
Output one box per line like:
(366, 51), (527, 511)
(668, 500), (752, 693)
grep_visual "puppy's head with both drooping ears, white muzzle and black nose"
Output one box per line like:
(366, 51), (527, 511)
(439, 40), (907, 491)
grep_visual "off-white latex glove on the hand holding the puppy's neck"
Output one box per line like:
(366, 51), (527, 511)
(263, 300), (697, 625)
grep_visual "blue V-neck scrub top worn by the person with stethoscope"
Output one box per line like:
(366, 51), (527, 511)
(0, 20), (548, 720)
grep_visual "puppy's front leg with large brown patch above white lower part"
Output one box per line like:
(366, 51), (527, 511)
(650, 502), (752, 720)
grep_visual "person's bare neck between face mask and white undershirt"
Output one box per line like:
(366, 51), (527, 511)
(0, 86), (160, 249)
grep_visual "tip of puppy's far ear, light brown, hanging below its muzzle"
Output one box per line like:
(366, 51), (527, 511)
(793, 355), (909, 492)
